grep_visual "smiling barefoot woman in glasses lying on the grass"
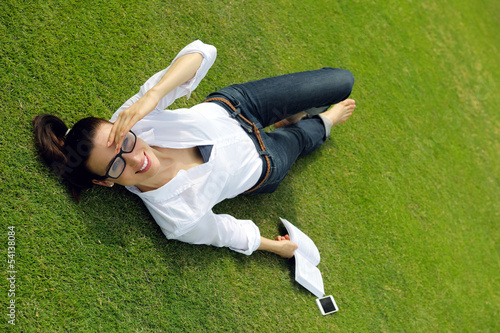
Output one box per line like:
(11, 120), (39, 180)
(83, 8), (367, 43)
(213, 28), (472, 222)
(33, 41), (355, 258)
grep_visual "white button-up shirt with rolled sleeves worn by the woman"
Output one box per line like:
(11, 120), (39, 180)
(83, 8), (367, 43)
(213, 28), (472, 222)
(111, 40), (262, 255)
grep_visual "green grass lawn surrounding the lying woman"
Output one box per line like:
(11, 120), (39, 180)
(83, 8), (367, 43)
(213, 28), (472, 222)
(0, 0), (500, 332)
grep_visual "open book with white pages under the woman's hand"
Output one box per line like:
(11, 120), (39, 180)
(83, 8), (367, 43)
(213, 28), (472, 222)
(280, 217), (325, 297)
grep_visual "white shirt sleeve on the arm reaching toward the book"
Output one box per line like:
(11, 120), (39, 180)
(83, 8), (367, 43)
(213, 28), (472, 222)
(157, 212), (260, 255)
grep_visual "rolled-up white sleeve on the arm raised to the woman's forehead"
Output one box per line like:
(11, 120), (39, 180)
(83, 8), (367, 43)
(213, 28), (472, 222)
(110, 40), (217, 122)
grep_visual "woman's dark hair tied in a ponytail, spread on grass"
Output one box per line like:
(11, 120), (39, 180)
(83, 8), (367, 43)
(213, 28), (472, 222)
(33, 114), (109, 200)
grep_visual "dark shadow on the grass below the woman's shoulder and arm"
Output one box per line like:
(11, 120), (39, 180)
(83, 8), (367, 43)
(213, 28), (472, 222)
(79, 183), (290, 269)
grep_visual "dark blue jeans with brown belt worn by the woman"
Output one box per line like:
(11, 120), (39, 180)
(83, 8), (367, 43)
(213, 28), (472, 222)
(207, 68), (354, 194)
